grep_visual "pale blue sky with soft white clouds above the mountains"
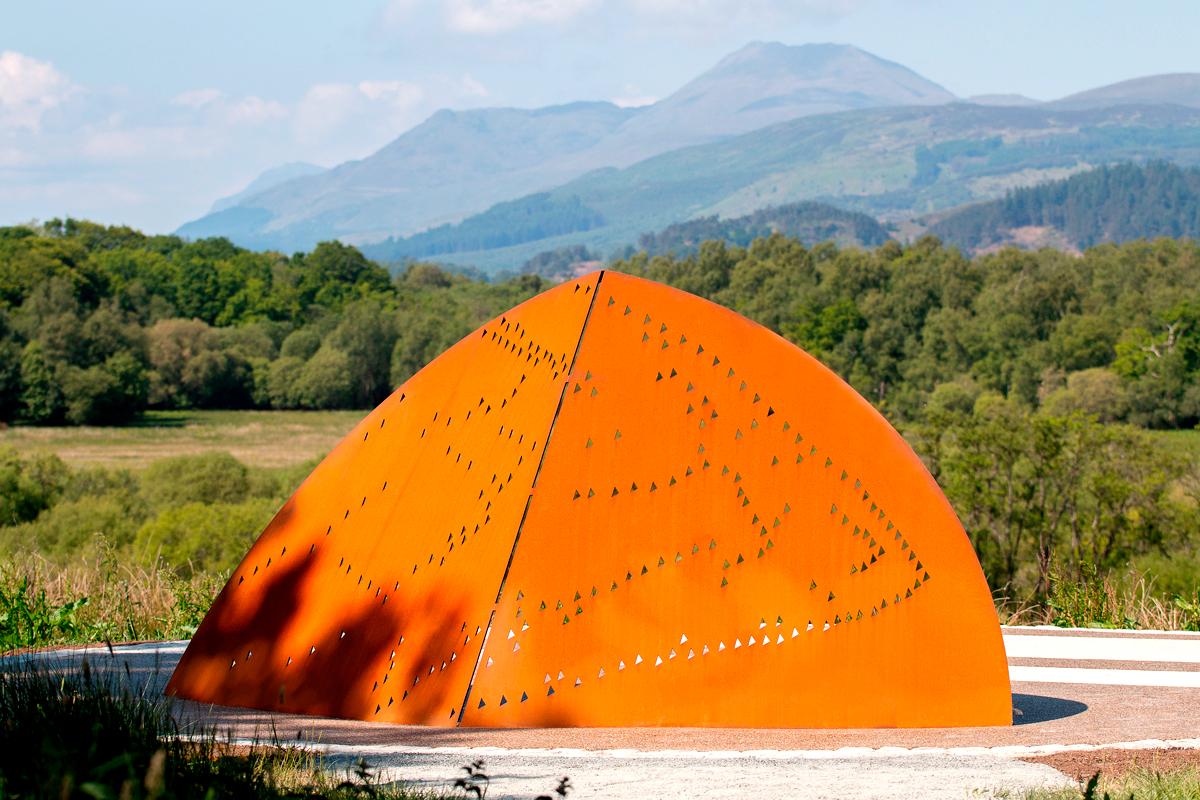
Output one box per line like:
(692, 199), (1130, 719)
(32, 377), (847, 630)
(0, 0), (1200, 233)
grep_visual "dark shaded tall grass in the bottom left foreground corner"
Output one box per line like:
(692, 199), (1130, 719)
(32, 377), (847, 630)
(0, 658), (443, 800)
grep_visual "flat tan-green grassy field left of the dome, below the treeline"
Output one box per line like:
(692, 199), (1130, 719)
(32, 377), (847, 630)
(0, 410), (367, 469)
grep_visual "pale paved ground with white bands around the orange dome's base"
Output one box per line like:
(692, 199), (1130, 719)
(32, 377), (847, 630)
(18, 627), (1200, 798)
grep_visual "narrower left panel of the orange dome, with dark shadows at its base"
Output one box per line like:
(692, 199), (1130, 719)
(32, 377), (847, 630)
(167, 276), (599, 724)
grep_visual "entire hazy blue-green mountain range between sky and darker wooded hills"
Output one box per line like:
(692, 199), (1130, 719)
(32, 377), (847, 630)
(180, 43), (1200, 269)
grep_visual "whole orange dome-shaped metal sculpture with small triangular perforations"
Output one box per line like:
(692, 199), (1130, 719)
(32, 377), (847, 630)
(167, 272), (1012, 727)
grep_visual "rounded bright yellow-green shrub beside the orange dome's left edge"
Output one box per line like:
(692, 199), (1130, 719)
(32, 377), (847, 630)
(134, 498), (278, 575)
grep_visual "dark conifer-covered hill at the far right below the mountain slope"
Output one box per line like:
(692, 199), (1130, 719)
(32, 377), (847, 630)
(929, 161), (1200, 252)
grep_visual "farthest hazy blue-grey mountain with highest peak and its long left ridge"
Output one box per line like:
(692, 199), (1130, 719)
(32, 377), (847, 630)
(179, 42), (954, 251)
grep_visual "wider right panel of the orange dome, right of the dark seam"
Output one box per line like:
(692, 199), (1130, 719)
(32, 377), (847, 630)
(463, 272), (1012, 727)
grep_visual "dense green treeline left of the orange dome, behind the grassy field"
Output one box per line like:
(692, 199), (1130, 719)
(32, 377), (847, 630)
(0, 219), (548, 425)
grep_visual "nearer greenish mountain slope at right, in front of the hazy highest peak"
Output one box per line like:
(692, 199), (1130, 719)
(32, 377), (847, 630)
(365, 103), (1200, 271)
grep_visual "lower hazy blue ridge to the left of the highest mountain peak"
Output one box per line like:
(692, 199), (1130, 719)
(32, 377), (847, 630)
(179, 103), (638, 251)
